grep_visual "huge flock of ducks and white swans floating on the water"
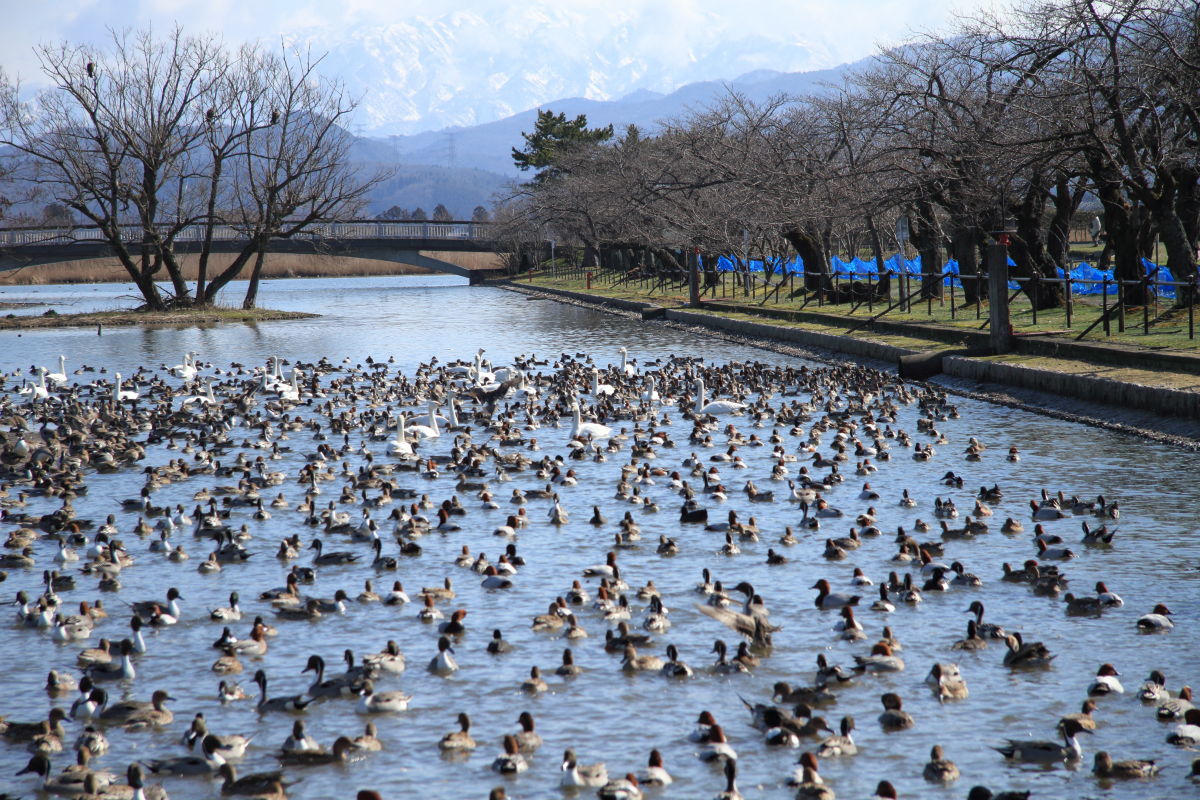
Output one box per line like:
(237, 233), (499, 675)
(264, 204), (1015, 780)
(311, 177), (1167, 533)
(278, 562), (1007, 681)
(0, 350), (1200, 800)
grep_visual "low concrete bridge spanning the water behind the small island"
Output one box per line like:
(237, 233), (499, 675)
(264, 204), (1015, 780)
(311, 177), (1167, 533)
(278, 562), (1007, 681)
(0, 221), (503, 284)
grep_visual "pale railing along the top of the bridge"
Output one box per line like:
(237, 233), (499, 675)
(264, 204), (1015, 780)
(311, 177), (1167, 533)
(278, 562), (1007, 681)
(0, 219), (491, 247)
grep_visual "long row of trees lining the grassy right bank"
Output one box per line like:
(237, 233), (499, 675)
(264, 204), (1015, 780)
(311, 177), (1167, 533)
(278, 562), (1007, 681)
(503, 0), (1200, 307)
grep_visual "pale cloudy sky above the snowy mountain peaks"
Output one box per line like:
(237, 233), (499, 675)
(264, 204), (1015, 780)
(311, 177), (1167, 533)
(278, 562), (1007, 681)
(0, 0), (1002, 133)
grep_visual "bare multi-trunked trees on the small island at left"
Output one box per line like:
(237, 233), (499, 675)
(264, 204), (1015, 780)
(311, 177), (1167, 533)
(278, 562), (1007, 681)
(0, 29), (385, 309)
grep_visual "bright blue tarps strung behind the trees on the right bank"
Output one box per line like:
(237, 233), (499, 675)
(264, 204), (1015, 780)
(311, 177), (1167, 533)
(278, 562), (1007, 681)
(716, 253), (1175, 297)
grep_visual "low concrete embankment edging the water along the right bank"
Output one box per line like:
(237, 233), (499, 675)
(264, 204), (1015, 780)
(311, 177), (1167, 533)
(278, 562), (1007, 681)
(490, 282), (1200, 451)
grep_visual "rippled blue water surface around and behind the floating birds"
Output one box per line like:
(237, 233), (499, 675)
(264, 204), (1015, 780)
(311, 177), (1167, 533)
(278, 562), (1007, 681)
(0, 277), (1200, 799)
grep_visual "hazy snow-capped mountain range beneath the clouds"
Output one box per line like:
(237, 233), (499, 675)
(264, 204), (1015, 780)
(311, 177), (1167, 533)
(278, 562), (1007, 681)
(289, 2), (834, 136)
